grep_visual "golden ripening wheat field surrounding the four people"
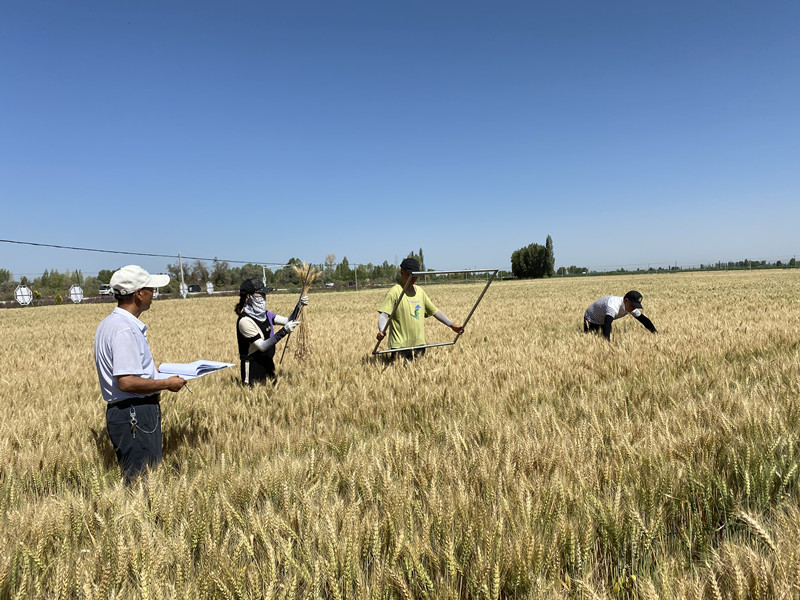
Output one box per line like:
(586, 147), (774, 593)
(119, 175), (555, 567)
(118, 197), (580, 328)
(0, 270), (800, 600)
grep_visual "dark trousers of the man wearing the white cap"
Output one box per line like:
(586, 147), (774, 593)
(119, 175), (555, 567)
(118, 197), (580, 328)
(106, 394), (161, 485)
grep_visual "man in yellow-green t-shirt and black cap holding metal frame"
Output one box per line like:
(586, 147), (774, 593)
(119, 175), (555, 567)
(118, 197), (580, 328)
(376, 258), (464, 360)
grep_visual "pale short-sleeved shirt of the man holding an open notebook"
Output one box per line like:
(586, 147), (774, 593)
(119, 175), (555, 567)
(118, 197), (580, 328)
(94, 307), (156, 402)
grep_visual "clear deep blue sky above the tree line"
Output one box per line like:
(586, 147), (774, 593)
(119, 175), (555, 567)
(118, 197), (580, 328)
(0, 0), (800, 276)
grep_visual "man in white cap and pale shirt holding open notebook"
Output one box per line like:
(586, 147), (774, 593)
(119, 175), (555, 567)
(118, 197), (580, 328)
(94, 265), (186, 484)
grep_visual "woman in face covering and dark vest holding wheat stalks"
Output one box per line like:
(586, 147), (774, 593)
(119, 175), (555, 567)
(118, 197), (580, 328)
(234, 278), (308, 385)
